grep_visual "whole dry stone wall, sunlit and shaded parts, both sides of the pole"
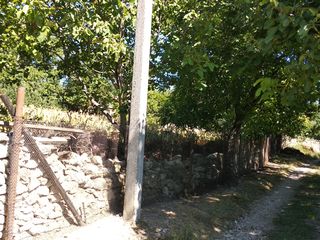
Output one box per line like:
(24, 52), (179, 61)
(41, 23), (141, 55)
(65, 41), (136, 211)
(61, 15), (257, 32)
(0, 129), (270, 240)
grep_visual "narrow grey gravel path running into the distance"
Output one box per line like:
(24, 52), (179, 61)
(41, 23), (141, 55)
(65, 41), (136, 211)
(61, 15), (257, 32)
(221, 163), (315, 240)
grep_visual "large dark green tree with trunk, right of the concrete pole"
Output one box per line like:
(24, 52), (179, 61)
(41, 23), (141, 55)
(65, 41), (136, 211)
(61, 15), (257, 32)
(154, 0), (318, 180)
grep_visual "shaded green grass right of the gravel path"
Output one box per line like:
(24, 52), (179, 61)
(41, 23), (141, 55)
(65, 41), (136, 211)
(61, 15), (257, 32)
(268, 175), (320, 240)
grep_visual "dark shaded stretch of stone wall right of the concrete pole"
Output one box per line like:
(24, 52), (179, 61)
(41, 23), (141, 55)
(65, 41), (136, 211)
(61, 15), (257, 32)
(142, 153), (223, 203)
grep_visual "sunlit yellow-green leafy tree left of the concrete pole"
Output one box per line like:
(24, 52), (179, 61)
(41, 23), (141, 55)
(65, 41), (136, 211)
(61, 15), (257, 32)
(0, 0), (136, 158)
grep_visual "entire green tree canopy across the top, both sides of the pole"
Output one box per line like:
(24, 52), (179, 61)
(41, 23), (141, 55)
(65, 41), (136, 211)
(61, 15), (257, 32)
(0, 0), (320, 167)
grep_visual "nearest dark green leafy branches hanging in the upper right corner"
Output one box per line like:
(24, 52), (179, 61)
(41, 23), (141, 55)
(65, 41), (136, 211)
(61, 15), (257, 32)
(260, 0), (320, 105)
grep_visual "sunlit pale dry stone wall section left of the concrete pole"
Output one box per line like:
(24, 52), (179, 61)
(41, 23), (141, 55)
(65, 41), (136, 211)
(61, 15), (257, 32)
(0, 133), (124, 240)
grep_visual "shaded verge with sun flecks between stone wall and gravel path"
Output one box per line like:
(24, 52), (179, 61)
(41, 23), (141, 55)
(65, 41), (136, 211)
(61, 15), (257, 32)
(139, 160), (295, 240)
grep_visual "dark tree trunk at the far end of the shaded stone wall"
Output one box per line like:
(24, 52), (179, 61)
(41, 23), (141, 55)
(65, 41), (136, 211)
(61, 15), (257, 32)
(222, 125), (241, 184)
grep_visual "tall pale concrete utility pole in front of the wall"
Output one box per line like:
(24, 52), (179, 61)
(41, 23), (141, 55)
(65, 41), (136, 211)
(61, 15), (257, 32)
(123, 0), (153, 224)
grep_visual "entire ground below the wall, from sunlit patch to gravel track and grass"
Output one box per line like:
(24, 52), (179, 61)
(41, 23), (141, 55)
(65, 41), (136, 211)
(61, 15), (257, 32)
(33, 153), (320, 240)
